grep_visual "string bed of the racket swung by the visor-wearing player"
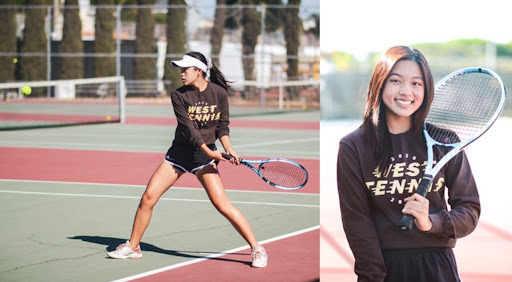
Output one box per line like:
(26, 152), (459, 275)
(259, 161), (308, 188)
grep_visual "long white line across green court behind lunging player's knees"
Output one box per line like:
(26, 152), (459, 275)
(0, 190), (320, 208)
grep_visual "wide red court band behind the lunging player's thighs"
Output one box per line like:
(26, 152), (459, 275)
(0, 147), (320, 193)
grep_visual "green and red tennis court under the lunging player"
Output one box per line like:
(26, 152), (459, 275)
(0, 100), (320, 281)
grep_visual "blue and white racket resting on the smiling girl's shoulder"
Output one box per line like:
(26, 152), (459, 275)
(398, 68), (506, 231)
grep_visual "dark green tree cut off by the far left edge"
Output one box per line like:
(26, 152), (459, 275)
(0, 0), (17, 82)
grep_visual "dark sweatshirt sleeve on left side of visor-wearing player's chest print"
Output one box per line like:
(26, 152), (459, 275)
(171, 91), (204, 148)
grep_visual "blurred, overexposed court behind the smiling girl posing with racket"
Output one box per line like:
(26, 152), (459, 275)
(320, 118), (512, 282)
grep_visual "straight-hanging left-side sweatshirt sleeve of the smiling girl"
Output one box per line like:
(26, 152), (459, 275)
(337, 140), (386, 281)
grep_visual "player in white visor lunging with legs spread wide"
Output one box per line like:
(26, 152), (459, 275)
(108, 52), (267, 267)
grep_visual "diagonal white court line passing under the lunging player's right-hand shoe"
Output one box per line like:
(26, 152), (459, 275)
(112, 225), (320, 282)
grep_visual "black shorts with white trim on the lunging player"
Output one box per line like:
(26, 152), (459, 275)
(165, 143), (217, 173)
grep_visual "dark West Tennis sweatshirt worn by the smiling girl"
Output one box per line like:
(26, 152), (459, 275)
(337, 128), (480, 281)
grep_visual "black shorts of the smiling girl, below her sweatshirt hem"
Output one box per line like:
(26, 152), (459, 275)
(382, 248), (461, 282)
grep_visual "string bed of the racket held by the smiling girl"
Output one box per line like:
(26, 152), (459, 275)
(426, 72), (502, 144)
